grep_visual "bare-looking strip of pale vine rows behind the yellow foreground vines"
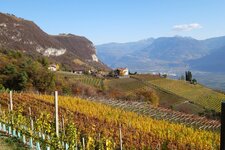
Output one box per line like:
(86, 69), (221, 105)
(89, 96), (221, 131)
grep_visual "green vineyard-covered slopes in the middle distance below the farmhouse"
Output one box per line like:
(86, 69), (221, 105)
(55, 72), (225, 114)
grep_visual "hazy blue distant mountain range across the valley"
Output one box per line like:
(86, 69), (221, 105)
(96, 36), (225, 73)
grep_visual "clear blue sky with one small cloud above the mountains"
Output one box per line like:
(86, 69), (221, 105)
(0, 0), (225, 45)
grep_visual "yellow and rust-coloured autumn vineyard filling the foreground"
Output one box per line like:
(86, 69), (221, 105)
(0, 93), (220, 150)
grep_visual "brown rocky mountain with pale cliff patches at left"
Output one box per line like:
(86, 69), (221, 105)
(0, 13), (109, 70)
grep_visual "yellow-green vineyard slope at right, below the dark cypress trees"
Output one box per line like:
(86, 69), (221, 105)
(149, 79), (225, 112)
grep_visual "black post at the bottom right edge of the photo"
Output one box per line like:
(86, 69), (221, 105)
(220, 102), (225, 150)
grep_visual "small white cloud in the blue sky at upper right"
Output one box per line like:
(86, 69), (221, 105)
(173, 23), (202, 31)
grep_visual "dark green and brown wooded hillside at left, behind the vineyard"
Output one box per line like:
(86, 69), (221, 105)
(0, 49), (55, 92)
